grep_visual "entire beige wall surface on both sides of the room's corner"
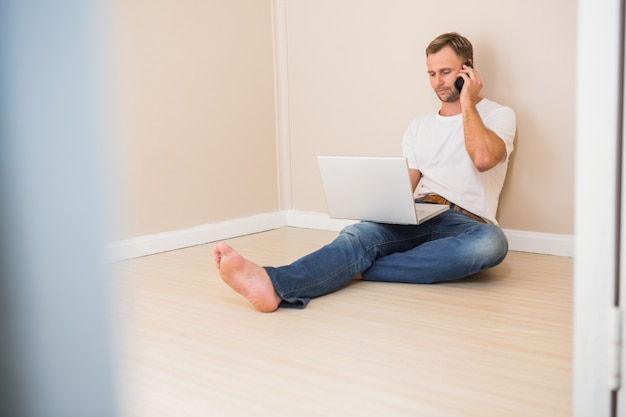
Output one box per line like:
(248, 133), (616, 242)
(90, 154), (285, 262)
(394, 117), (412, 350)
(111, 0), (576, 239)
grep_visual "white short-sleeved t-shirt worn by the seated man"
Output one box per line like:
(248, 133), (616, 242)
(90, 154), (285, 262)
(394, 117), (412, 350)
(402, 99), (516, 224)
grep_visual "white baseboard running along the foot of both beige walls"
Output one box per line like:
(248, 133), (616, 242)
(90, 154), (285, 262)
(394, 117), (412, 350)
(107, 210), (574, 262)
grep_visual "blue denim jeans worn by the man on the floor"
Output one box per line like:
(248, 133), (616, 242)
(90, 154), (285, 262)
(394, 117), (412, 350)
(265, 210), (508, 308)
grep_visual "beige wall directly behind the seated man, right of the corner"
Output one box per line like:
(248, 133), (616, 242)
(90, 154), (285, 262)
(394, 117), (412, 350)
(287, 0), (576, 234)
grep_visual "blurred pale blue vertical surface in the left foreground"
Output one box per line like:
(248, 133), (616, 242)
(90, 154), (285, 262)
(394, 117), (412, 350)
(0, 0), (117, 417)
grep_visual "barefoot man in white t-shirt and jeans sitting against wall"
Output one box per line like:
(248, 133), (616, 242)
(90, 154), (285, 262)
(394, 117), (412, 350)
(213, 33), (516, 312)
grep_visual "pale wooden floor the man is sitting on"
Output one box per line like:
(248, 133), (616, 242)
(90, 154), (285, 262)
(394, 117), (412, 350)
(116, 228), (573, 417)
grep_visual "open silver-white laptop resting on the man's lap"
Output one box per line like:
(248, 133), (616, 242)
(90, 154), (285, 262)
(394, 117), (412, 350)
(317, 156), (450, 224)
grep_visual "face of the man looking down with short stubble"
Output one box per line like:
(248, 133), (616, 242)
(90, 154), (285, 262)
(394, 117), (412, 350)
(426, 46), (463, 103)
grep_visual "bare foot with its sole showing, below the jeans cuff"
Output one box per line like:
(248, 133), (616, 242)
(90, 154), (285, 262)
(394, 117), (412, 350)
(213, 243), (281, 313)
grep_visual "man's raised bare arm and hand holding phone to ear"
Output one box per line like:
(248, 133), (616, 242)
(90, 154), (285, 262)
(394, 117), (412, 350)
(461, 66), (506, 172)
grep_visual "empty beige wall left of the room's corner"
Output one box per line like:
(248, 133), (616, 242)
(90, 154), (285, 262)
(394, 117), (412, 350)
(115, 0), (278, 239)
